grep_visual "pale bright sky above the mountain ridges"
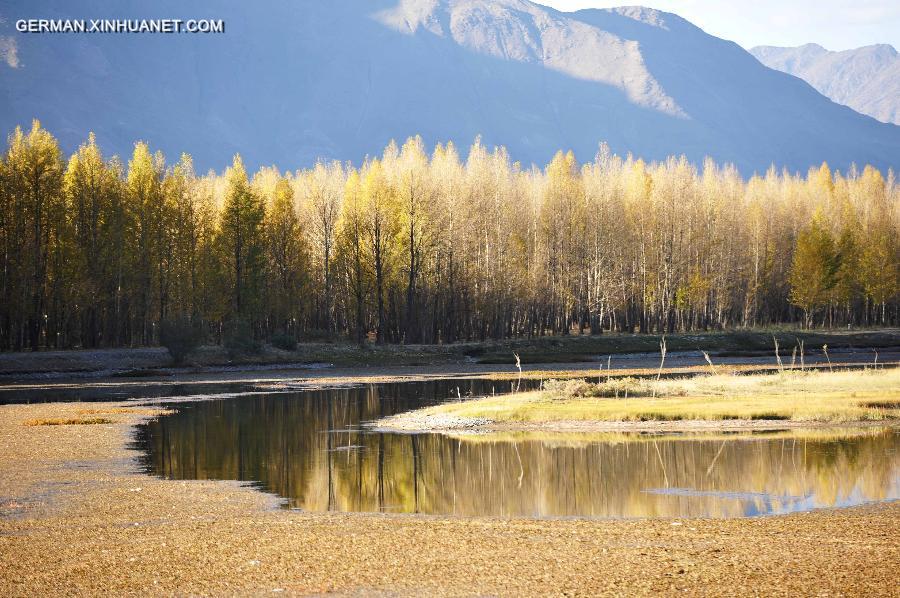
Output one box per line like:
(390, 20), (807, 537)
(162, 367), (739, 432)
(536, 0), (900, 50)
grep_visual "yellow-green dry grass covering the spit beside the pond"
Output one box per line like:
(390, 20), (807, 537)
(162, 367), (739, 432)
(426, 369), (900, 422)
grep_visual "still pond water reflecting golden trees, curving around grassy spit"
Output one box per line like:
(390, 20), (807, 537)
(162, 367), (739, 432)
(137, 380), (900, 518)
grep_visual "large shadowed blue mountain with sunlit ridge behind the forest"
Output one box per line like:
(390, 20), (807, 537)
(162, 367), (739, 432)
(0, 0), (900, 175)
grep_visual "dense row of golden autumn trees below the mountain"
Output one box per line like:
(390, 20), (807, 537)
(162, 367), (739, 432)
(0, 121), (900, 350)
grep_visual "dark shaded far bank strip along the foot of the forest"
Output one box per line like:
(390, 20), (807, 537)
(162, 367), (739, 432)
(0, 329), (900, 382)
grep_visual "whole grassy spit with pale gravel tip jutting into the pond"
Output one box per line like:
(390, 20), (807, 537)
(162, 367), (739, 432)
(373, 368), (900, 432)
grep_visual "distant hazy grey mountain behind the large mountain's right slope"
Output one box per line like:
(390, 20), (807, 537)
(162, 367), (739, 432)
(750, 44), (900, 125)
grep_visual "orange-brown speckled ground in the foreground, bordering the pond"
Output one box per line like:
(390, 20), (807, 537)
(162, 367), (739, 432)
(0, 403), (900, 596)
